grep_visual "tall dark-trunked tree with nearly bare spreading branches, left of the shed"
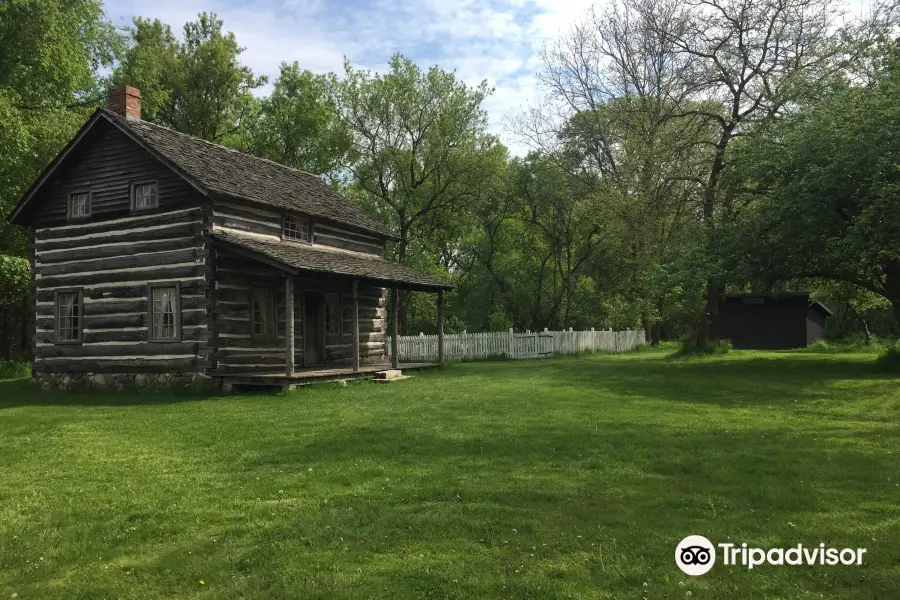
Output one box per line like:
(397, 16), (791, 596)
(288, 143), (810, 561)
(653, 0), (885, 345)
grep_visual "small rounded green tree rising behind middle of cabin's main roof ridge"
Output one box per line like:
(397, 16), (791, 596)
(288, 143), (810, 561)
(245, 62), (350, 175)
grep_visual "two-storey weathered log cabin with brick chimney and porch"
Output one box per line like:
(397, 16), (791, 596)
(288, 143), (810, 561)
(9, 86), (450, 392)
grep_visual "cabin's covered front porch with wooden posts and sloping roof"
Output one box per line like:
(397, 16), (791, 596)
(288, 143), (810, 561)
(208, 231), (450, 388)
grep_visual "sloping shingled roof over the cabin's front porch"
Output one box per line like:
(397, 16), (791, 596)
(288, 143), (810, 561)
(212, 230), (453, 292)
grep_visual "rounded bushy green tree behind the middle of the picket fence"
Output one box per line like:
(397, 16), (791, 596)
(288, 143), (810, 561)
(453, 153), (601, 330)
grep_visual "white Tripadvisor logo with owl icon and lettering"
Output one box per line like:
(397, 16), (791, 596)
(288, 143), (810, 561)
(675, 535), (867, 576)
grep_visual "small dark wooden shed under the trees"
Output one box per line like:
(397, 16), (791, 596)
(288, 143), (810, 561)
(721, 292), (833, 350)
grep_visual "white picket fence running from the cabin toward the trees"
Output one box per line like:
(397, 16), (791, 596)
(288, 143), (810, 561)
(388, 329), (644, 362)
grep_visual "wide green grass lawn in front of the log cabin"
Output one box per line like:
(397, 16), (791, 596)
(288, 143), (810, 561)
(0, 351), (900, 600)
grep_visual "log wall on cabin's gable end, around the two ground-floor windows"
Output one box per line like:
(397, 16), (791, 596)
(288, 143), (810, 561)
(33, 209), (210, 373)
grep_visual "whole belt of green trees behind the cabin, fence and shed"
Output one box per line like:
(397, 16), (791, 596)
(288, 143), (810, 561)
(0, 0), (900, 345)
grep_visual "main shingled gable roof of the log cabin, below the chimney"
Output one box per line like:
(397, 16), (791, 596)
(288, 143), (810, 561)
(9, 108), (397, 239)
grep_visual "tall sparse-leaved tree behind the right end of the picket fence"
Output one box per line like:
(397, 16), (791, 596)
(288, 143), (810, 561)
(517, 0), (715, 342)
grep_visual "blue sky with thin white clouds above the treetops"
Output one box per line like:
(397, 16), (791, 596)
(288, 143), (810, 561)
(106, 0), (591, 150)
